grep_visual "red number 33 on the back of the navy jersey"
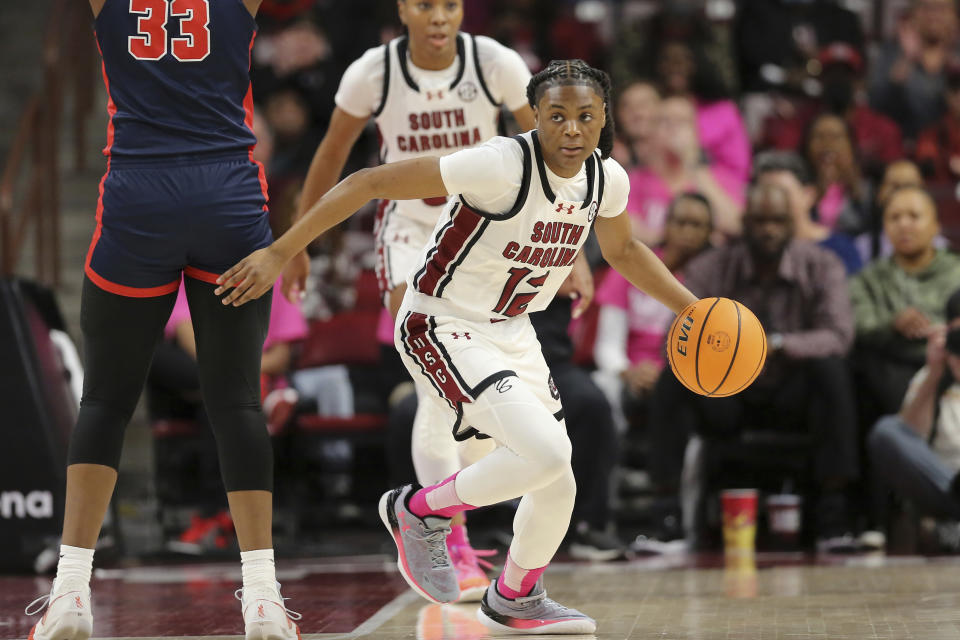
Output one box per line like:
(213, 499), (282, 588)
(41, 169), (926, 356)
(127, 0), (210, 62)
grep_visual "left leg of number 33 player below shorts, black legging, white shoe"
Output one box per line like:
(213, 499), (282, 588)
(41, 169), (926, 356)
(31, 278), (176, 640)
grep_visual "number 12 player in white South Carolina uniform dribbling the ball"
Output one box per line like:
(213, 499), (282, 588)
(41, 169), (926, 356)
(217, 60), (696, 633)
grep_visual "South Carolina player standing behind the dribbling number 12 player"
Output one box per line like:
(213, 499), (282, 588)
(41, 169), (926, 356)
(284, 0), (568, 601)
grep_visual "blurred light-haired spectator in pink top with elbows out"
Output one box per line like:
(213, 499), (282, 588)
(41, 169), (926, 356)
(627, 98), (743, 245)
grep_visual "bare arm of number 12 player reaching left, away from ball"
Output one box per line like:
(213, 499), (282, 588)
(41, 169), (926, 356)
(215, 157), (448, 306)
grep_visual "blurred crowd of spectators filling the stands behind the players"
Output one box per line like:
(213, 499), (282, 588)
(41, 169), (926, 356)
(146, 0), (960, 551)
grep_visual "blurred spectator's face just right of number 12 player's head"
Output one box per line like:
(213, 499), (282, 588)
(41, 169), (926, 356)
(613, 80), (660, 170)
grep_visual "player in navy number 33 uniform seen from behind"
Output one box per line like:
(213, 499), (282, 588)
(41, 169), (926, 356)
(28, 0), (299, 640)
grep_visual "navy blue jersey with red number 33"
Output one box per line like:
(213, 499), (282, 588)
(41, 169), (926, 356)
(95, 0), (257, 157)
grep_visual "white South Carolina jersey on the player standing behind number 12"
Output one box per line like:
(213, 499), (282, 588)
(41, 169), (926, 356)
(373, 33), (500, 226)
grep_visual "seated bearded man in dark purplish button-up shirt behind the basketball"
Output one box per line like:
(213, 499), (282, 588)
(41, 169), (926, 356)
(649, 184), (858, 551)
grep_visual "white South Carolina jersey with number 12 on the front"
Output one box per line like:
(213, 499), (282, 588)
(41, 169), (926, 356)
(407, 131), (604, 320)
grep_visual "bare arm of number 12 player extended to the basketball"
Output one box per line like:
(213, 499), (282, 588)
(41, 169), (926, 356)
(594, 211), (697, 313)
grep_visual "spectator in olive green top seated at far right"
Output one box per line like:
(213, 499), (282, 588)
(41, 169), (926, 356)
(850, 187), (960, 424)
